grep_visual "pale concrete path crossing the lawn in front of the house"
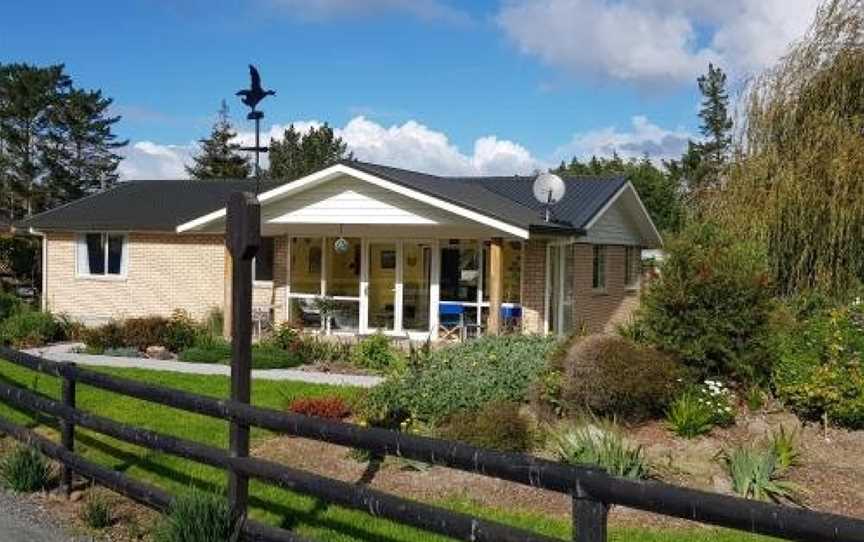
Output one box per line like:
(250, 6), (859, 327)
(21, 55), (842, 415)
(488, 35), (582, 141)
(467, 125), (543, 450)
(24, 343), (384, 388)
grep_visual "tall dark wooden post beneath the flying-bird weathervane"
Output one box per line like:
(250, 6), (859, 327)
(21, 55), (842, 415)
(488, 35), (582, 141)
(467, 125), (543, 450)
(225, 192), (261, 522)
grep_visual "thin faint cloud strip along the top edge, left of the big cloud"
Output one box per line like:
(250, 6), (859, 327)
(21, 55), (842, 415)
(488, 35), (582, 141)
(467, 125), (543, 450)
(267, 0), (469, 23)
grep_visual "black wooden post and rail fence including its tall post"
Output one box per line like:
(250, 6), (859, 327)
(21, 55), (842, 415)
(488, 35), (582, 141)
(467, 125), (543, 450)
(0, 194), (864, 542)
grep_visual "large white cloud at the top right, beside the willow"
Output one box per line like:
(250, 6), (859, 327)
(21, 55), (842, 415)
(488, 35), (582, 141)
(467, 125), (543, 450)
(497, 0), (820, 84)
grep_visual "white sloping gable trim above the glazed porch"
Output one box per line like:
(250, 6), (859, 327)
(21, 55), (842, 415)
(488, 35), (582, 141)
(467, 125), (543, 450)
(177, 164), (528, 239)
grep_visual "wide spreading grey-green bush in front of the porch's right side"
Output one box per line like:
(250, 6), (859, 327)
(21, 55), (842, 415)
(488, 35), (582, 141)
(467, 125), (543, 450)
(360, 335), (555, 425)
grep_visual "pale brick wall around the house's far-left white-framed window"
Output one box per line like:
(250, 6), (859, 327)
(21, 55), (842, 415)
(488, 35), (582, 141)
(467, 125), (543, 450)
(45, 233), (274, 324)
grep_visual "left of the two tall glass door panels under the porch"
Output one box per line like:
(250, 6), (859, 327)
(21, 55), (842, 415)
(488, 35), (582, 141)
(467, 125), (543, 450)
(366, 241), (399, 331)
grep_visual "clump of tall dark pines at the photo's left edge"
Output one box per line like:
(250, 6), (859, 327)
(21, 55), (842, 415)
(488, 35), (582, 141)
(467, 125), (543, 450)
(0, 64), (128, 220)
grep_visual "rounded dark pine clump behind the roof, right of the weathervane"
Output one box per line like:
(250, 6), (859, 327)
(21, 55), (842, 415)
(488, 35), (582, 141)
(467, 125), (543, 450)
(269, 124), (353, 180)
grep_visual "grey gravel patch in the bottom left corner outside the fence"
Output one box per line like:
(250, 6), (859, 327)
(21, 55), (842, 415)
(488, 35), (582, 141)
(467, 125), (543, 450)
(0, 491), (75, 542)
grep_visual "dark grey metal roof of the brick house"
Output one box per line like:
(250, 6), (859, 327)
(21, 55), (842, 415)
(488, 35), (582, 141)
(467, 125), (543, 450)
(19, 160), (627, 234)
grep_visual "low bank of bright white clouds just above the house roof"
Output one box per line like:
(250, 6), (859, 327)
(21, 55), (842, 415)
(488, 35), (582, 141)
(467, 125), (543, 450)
(119, 116), (543, 180)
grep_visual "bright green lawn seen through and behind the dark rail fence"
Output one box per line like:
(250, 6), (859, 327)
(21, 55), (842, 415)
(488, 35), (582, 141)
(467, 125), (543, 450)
(0, 361), (768, 542)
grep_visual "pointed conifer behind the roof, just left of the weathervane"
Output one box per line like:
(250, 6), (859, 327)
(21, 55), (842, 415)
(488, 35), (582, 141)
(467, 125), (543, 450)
(186, 100), (252, 179)
